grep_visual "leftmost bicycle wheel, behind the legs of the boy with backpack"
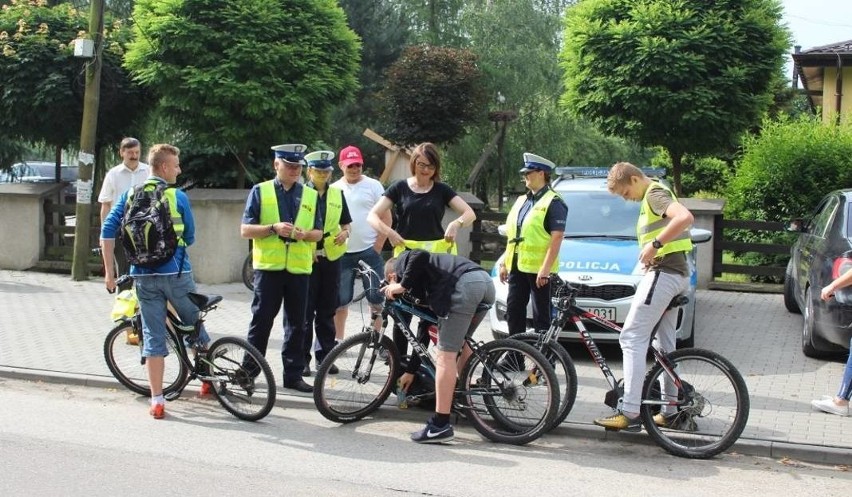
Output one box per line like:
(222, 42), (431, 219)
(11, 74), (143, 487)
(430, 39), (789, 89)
(104, 321), (189, 397)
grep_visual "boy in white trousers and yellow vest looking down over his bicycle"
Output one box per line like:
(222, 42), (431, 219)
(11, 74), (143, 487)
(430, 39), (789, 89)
(595, 162), (693, 432)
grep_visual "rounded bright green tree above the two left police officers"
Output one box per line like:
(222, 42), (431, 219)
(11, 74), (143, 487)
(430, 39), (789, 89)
(125, 0), (359, 188)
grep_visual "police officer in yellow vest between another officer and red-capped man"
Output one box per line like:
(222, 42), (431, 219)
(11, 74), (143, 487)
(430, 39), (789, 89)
(302, 150), (352, 376)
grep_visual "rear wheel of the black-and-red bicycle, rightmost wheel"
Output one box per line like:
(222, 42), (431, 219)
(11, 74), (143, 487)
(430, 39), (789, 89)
(640, 348), (749, 459)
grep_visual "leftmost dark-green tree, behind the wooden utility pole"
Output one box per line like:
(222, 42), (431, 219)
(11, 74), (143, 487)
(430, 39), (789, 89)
(0, 0), (150, 163)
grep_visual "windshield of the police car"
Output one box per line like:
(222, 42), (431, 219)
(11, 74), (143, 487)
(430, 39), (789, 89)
(559, 191), (639, 240)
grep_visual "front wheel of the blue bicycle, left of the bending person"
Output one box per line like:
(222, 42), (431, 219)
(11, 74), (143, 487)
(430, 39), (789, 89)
(314, 331), (399, 423)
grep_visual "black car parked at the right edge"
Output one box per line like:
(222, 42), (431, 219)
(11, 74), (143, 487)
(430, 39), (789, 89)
(784, 189), (852, 357)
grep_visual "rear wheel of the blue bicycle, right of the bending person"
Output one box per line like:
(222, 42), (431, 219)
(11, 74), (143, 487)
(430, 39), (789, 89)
(456, 339), (559, 445)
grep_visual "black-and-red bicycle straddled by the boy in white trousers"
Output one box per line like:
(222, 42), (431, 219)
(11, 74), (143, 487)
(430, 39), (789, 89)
(526, 274), (749, 459)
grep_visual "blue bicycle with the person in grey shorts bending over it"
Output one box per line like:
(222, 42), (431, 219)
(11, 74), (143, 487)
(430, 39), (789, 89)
(314, 261), (559, 445)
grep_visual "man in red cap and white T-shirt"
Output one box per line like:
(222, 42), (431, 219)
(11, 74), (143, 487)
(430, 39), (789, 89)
(331, 145), (392, 341)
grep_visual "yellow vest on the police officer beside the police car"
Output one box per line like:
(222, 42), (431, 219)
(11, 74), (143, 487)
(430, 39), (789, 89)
(504, 188), (559, 273)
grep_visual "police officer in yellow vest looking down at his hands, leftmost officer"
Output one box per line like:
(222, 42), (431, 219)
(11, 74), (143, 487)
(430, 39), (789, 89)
(240, 145), (323, 392)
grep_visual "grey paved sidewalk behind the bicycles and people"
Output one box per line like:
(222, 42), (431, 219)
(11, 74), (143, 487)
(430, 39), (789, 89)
(0, 270), (852, 464)
